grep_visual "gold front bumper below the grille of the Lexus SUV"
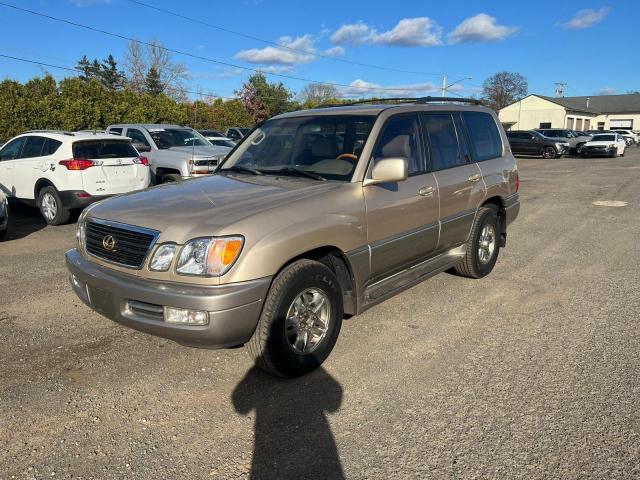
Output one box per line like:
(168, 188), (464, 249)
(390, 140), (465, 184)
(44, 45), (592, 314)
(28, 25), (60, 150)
(66, 249), (271, 348)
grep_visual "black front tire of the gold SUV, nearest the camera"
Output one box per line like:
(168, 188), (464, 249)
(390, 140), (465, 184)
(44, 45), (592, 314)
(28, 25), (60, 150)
(247, 260), (343, 377)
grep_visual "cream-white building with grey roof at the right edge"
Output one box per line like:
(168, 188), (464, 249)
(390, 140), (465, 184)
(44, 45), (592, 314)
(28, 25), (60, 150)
(498, 93), (640, 130)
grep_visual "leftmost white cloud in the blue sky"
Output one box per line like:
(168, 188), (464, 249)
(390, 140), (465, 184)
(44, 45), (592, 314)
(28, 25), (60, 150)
(235, 34), (315, 65)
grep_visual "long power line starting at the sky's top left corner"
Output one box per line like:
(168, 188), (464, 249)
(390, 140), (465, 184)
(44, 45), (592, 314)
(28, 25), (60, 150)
(0, 2), (444, 92)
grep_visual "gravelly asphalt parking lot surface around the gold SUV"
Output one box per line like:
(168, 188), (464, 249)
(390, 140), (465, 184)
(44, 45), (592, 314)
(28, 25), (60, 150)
(0, 147), (640, 479)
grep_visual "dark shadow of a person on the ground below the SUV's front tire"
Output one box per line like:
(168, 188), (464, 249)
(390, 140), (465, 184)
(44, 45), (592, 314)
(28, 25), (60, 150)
(232, 367), (345, 480)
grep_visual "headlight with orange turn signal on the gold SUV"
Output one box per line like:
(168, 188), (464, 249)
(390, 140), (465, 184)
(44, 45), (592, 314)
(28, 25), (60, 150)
(176, 236), (244, 277)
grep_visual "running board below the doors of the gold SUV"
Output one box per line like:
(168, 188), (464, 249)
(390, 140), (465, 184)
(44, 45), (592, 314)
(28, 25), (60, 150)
(362, 245), (466, 310)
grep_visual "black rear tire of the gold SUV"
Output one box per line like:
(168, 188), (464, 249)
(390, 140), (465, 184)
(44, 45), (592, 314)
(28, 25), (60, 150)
(454, 205), (500, 278)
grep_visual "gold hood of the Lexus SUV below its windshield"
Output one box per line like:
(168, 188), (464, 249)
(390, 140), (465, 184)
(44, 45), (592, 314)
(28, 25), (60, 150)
(89, 174), (340, 243)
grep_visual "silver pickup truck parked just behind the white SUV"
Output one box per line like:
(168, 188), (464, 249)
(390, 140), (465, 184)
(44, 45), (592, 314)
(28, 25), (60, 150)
(107, 124), (231, 183)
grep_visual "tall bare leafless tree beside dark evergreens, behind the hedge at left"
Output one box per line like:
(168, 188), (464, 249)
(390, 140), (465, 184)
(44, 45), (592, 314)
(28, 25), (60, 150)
(124, 38), (191, 100)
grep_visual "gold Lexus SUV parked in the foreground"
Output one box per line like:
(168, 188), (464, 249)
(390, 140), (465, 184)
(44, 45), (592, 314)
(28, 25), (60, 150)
(66, 97), (520, 376)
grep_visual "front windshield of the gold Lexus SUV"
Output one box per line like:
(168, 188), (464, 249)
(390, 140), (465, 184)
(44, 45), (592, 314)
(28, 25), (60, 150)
(221, 115), (375, 181)
